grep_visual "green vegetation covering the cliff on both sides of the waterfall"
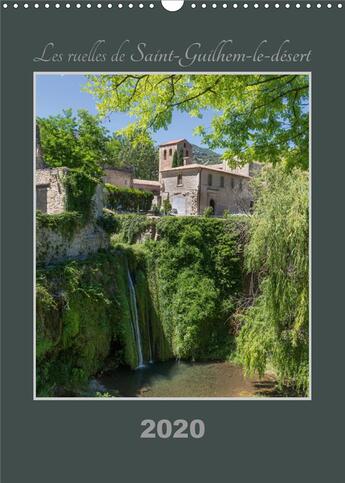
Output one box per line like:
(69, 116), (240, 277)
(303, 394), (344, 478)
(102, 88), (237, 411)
(36, 215), (246, 395)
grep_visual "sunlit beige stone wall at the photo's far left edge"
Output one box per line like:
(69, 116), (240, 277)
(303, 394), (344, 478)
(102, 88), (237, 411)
(36, 168), (67, 213)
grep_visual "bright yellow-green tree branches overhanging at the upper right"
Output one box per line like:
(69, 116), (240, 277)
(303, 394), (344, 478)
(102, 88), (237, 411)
(85, 74), (309, 169)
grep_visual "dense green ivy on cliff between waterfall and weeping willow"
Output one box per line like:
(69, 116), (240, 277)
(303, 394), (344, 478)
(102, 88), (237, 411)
(146, 217), (242, 360)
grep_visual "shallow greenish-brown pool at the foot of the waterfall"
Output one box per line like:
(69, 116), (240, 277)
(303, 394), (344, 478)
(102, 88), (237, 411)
(94, 361), (272, 397)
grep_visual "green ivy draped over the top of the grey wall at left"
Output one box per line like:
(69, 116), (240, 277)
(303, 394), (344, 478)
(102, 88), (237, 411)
(36, 211), (83, 240)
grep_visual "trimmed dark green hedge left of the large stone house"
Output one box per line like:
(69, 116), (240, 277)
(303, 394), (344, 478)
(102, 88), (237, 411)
(106, 184), (153, 211)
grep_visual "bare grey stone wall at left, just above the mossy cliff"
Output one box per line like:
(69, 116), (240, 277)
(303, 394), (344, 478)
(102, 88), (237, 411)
(36, 223), (109, 265)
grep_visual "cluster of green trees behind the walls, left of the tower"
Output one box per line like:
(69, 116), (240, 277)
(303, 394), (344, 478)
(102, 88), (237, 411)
(37, 109), (158, 179)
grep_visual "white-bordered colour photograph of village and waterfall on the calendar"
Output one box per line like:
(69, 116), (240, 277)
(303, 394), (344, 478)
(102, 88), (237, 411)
(33, 72), (311, 401)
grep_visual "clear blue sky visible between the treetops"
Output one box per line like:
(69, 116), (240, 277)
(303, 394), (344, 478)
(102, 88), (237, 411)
(36, 74), (218, 147)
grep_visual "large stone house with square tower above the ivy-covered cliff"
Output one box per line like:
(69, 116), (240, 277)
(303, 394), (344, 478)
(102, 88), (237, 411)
(159, 139), (252, 216)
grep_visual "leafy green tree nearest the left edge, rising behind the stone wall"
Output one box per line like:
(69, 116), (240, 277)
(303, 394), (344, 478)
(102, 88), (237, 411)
(37, 109), (119, 177)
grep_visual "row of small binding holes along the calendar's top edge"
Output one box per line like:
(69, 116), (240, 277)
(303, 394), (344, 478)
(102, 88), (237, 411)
(2, 2), (343, 9)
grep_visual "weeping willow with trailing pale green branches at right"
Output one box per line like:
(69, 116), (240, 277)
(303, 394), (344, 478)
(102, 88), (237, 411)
(238, 168), (309, 394)
